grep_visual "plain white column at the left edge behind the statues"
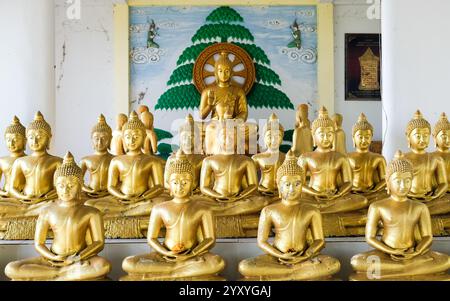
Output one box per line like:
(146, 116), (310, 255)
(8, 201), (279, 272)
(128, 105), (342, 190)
(0, 0), (55, 155)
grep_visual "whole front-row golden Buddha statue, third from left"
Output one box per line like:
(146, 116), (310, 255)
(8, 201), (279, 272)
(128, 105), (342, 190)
(239, 150), (340, 280)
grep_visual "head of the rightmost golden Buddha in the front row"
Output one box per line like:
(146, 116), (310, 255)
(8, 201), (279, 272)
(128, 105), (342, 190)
(386, 150), (413, 198)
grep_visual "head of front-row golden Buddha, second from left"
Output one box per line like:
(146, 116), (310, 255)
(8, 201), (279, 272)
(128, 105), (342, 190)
(166, 149), (194, 199)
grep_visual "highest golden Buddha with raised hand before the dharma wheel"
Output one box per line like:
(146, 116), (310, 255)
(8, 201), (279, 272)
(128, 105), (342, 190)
(200, 52), (249, 154)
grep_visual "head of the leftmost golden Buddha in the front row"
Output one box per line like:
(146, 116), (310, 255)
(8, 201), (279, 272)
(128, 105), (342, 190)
(54, 152), (83, 202)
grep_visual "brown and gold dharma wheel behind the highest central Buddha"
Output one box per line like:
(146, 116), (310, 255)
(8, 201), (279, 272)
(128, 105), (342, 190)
(193, 43), (255, 94)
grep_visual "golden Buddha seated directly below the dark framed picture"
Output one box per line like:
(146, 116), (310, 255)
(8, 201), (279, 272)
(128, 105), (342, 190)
(348, 113), (389, 203)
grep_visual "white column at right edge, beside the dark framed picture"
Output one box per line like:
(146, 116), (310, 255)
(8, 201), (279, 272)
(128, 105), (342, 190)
(381, 0), (450, 161)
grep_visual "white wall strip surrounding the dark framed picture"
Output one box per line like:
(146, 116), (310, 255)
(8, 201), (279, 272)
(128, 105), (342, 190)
(334, 0), (382, 151)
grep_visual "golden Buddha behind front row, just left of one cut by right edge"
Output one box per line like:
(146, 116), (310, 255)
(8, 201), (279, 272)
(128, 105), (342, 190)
(405, 111), (450, 215)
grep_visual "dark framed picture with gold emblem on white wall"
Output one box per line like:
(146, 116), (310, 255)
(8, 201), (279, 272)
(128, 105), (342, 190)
(345, 33), (381, 100)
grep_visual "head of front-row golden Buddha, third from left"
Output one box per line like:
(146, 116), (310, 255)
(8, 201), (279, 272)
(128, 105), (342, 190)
(277, 150), (305, 201)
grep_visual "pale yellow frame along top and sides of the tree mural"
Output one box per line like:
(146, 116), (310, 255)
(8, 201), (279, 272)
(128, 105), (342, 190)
(113, 0), (334, 114)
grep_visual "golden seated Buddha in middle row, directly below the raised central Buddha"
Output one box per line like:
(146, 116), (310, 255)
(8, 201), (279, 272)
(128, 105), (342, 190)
(200, 125), (273, 237)
